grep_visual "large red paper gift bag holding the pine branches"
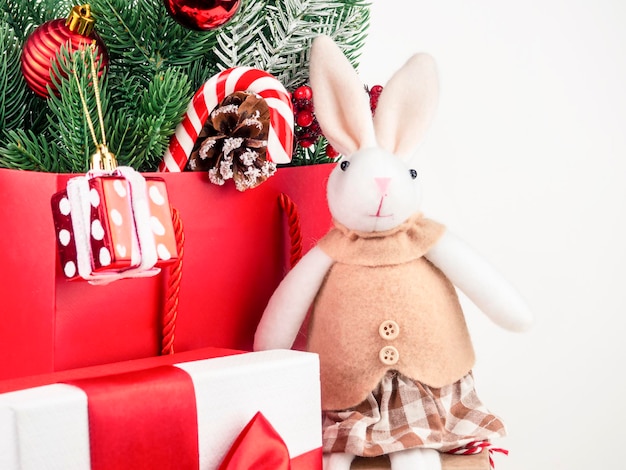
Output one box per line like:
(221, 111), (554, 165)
(0, 165), (333, 379)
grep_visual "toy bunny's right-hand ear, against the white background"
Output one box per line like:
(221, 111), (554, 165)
(374, 54), (439, 157)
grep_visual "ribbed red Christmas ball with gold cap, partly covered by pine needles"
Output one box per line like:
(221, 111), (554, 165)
(21, 5), (109, 98)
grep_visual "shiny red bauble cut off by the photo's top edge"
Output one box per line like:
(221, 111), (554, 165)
(163, 0), (241, 31)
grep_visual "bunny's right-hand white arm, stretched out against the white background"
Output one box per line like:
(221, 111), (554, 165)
(425, 230), (533, 332)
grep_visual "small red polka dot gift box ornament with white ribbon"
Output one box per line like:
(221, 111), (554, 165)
(51, 167), (177, 284)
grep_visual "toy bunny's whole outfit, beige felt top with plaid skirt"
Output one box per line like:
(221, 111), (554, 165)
(308, 215), (504, 457)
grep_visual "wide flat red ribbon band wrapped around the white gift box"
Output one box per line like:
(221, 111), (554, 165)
(69, 366), (198, 470)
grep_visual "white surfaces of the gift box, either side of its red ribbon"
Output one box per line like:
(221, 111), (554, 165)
(0, 348), (322, 470)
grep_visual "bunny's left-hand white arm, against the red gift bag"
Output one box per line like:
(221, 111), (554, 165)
(254, 247), (334, 351)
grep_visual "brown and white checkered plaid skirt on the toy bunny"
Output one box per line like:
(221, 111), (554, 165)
(323, 371), (505, 457)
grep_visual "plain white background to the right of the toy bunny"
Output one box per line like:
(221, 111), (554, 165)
(360, 0), (626, 470)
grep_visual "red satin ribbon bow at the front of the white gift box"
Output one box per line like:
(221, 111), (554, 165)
(219, 412), (291, 470)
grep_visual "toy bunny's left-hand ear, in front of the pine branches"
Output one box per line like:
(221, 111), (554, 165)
(309, 36), (376, 156)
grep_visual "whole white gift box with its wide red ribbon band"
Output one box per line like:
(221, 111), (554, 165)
(0, 348), (322, 470)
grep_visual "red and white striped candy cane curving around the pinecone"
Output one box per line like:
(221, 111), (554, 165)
(159, 67), (293, 172)
